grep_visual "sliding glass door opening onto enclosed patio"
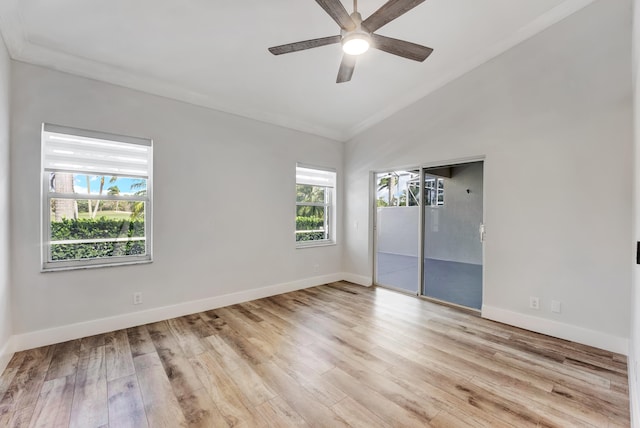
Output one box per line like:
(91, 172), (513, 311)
(374, 161), (484, 310)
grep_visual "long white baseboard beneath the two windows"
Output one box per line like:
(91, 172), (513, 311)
(12, 273), (343, 352)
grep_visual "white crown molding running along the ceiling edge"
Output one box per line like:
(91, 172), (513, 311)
(0, 0), (595, 142)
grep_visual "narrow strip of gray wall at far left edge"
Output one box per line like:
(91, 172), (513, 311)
(0, 37), (12, 373)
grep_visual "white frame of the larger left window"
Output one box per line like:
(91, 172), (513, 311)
(40, 123), (153, 272)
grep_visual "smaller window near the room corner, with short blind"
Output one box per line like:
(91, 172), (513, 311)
(296, 165), (336, 247)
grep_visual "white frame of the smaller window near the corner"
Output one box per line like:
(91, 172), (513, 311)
(294, 163), (338, 248)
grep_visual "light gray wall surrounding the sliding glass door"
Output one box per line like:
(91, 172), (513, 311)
(344, 0), (633, 352)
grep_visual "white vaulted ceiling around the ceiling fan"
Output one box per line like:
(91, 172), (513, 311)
(0, 0), (593, 140)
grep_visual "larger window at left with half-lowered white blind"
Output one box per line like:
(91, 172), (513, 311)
(42, 124), (153, 270)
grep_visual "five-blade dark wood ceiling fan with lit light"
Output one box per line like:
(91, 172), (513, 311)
(269, 0), (433, 83)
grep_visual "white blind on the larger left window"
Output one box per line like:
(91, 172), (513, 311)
(42, 124), (152, 178)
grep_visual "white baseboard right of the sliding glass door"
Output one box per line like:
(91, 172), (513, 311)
(482, 305), (629, 355)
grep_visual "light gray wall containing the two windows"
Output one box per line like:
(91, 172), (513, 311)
(11, 62), (344, 334)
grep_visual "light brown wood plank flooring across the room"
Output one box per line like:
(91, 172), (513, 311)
(0, 282), (630, 428)
